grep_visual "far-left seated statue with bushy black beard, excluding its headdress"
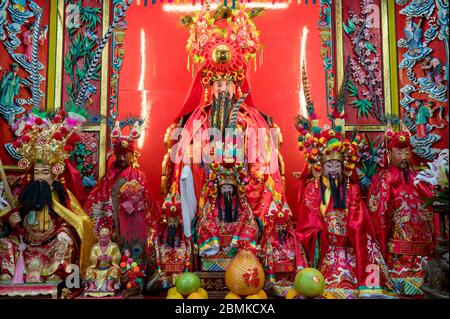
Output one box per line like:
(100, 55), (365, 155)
(0, 163), (93, 284)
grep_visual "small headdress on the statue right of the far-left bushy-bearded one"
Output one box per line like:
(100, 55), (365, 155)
(111, 118), (144, 154)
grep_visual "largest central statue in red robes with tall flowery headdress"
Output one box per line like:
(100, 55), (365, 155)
(156, 5), (294, 284)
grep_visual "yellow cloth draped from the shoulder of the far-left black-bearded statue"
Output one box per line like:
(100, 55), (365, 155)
(52, 190), (96, 274)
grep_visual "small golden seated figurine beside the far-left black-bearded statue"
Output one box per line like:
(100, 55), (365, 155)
(84, 227), (121, 297)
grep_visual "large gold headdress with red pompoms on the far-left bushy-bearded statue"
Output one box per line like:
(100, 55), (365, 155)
(13, 110), (86, 175)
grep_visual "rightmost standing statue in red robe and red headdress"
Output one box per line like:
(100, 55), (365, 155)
(367, 124), (439, 295)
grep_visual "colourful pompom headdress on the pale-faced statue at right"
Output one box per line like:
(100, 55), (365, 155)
(297, 116), (359, 176)
